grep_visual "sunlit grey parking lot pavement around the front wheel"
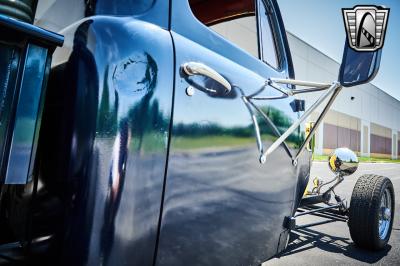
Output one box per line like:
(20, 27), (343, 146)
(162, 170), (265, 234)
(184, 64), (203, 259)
(263, 162), (400, 266)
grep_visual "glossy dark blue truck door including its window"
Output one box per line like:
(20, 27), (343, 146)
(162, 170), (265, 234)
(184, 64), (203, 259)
(156, 0), (308, 265)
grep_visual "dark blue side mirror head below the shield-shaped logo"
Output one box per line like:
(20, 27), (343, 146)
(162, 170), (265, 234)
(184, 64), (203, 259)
(339, 41), (382, 87)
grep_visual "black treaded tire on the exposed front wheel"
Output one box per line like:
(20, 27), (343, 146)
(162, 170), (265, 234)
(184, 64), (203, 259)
(348, 175), (395, 250)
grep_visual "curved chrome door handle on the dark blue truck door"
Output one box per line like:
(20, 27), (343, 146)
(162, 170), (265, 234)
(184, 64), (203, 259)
(181, 62), (232, 94)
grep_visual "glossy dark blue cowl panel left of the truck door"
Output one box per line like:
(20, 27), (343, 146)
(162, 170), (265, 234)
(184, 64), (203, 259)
(38, 1), (174, 265)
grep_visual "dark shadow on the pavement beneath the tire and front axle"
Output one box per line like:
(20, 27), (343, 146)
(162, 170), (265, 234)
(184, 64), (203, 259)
(278, 228), (392, 263)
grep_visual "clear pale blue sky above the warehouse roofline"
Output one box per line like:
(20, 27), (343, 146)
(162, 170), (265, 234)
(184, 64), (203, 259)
(277, 0), (400, 100)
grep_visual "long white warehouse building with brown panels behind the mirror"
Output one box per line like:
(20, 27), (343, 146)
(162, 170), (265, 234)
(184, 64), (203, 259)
(288, 33), (400, 158)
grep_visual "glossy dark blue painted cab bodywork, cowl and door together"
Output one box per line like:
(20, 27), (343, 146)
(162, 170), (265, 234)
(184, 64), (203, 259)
(16, 0), (310, 265)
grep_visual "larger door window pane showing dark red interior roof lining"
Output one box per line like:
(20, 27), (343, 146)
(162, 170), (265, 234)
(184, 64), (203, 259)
(189, 0), (260, 58)
